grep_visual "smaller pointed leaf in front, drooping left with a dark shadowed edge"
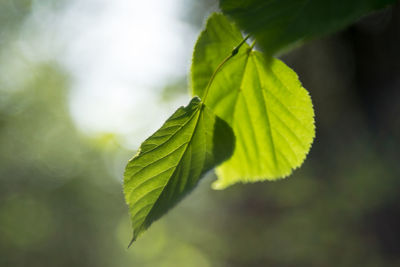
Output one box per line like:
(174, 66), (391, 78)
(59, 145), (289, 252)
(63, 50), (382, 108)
(124, 97), (235, 242)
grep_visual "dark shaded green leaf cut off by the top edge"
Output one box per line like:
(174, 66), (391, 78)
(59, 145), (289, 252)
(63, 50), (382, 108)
(220, 0), (396, 55)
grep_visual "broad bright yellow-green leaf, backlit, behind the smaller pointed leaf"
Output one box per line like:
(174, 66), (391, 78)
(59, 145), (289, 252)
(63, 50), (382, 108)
(192, 14), (315, 189)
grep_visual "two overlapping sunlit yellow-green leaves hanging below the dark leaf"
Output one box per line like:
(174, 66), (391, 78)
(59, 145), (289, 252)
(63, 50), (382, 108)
(124, 14), (315, 245)
